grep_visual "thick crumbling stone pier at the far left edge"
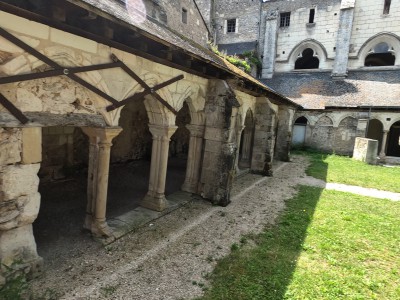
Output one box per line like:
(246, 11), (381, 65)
(0, 127), (42, 289)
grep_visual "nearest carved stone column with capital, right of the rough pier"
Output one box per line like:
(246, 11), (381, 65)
(82, 127), (122, 237)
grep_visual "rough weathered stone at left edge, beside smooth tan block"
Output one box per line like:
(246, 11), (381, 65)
(0, 128), (21, 165)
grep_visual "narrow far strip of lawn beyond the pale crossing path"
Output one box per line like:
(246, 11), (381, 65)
(293, 151), (400, 193)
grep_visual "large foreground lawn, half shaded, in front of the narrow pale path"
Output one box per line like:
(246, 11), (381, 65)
(201, 186), (400, 300)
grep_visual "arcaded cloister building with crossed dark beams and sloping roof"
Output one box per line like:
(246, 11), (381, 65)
(0, 0), (299, 284)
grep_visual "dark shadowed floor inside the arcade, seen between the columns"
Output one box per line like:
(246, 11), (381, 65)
(33, 157), (186, 260)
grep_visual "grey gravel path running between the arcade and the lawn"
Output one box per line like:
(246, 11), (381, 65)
(32, 156), (398, 300)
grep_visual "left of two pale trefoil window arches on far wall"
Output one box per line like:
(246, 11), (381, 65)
(288, 39), (328, 69)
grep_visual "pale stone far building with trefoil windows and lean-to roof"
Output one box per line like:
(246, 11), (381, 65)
(203, 0), (400, 159)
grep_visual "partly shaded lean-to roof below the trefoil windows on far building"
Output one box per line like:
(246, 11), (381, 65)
(262, 69), (400, 109)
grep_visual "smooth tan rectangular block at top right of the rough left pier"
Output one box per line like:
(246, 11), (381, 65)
(22, 127), (42, 164)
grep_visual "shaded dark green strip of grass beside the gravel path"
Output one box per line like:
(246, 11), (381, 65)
(200, 154), (327, 299)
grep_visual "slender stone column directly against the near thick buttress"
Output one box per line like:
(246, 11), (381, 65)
(182, 124), (205, 193)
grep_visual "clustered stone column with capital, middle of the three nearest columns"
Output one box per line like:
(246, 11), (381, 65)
(140, 124), (178, 211)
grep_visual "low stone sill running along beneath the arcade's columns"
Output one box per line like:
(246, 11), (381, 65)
(99, 191), (195, 246)
